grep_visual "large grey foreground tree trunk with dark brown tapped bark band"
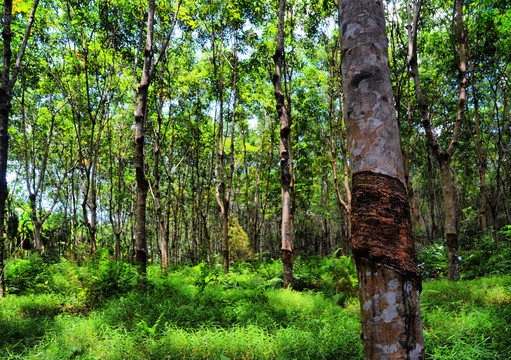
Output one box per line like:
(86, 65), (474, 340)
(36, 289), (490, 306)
(340, 0), (424, 360)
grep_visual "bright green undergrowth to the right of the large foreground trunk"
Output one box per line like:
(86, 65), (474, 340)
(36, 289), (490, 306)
(421, 275), (511, 360)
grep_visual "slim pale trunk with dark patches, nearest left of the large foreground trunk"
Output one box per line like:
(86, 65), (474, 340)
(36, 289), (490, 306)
(273, 0), (293, 289)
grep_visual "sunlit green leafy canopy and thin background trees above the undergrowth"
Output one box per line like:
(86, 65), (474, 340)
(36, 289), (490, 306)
(2, 0), (511, 284)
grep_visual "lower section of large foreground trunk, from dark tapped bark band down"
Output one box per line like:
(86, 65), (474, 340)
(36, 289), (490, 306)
(352, 172), (424, 359)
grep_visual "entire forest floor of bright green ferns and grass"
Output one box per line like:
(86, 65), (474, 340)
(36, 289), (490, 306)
(0, 258), (511, 360)
